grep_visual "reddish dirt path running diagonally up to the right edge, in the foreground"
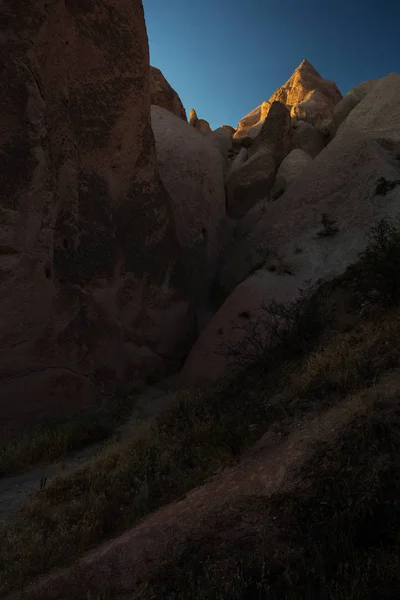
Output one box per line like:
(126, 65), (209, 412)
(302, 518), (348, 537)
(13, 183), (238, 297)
(8, 372), (400, 600)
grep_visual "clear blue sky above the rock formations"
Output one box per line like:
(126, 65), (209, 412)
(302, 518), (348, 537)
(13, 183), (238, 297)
(143, 0), (400, 129)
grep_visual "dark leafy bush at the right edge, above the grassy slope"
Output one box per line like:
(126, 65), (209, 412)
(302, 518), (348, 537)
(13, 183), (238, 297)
(348, 219), (400, 308)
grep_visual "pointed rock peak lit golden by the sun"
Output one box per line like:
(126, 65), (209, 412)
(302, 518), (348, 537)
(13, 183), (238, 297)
(269, 60), (342, 124)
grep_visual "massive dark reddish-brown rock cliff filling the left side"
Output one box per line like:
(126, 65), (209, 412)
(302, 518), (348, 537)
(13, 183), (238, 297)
(0, 0), (192, 427)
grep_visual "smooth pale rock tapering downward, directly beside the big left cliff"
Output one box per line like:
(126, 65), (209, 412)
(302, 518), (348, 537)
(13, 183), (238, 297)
(151, 106), (226, 304)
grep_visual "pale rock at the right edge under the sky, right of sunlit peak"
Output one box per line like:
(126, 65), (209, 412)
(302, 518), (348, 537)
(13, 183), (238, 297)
(336, 73), (400, 144)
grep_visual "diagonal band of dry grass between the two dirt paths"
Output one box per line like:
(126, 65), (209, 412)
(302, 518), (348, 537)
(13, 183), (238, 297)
(0, 300), (400, 590)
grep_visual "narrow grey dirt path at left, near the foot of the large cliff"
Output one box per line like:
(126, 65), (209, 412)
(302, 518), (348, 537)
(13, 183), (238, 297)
(0, 387), (170, 521)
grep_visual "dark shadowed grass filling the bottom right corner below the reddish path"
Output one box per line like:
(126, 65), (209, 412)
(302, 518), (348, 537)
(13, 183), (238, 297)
(143, 396), (400, 600)
